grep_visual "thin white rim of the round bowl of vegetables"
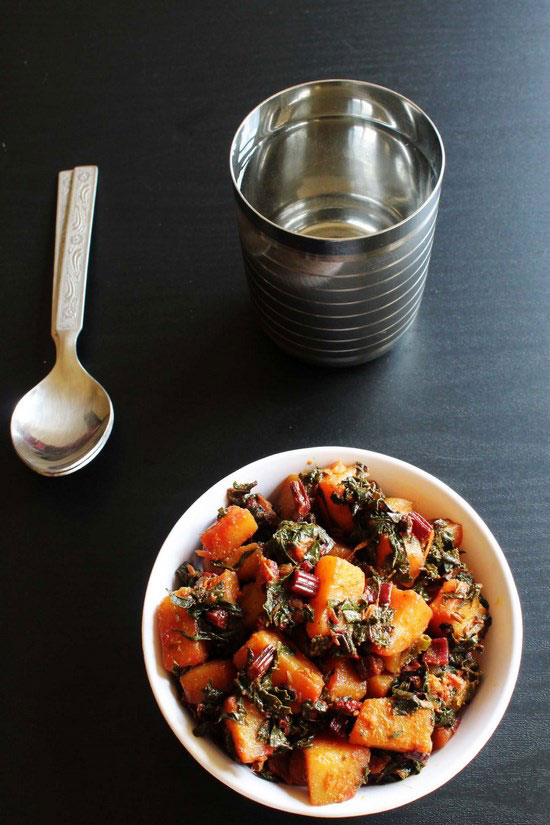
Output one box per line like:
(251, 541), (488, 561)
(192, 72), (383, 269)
(141, 446), (523, 818)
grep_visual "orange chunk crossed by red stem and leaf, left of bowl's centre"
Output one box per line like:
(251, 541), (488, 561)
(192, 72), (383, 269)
(233, 630), (325, 710)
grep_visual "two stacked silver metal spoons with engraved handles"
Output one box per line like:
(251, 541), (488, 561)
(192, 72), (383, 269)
(11, 166), (114, 476)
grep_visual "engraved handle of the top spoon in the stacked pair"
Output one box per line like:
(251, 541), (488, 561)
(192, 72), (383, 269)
(53, 166), (97, 333)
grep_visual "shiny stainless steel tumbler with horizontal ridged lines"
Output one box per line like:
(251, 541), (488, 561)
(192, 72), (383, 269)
(230, 80), (445, 366)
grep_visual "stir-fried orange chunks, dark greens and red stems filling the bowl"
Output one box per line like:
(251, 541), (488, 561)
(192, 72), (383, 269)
(157, 463), (491, 805)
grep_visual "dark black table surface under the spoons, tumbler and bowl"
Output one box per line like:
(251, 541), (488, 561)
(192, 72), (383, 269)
(0, 0), (550, 825)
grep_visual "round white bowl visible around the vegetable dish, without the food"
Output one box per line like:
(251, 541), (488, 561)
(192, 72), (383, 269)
(142, 447), (522, 817)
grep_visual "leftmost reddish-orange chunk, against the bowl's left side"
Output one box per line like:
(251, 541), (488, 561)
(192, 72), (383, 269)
(157, 587), (208, 671)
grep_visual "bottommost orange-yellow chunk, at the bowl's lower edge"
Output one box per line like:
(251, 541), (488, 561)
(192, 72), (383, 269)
(303, 737), (370, 805)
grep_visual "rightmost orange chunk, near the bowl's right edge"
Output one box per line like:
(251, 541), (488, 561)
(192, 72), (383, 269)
(430, 579), (487, 640)
